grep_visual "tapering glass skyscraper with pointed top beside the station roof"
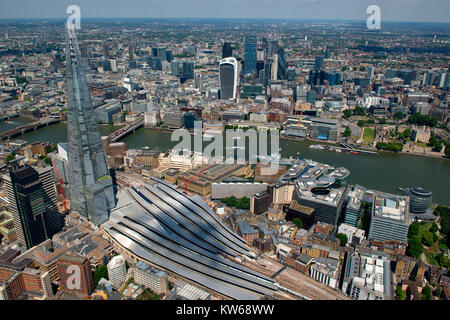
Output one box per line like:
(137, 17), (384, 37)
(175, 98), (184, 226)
(66, 30), (116, 224)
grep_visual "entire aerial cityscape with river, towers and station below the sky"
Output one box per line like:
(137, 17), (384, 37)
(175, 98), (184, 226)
(0, 1), (450, 304)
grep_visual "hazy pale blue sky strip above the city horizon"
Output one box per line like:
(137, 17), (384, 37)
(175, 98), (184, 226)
(0, 0), (450, 22)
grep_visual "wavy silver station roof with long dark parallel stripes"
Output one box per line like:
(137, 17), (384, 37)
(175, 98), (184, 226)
(102, 183), (277, 300)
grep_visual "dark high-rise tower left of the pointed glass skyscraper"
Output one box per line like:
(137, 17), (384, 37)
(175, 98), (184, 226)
(3, 164), (64, 249)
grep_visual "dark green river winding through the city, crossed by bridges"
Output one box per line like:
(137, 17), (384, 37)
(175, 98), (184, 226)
(0, 118), (450, 206)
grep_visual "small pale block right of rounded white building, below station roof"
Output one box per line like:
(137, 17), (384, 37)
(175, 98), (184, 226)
(134, 261), (169, 294)
